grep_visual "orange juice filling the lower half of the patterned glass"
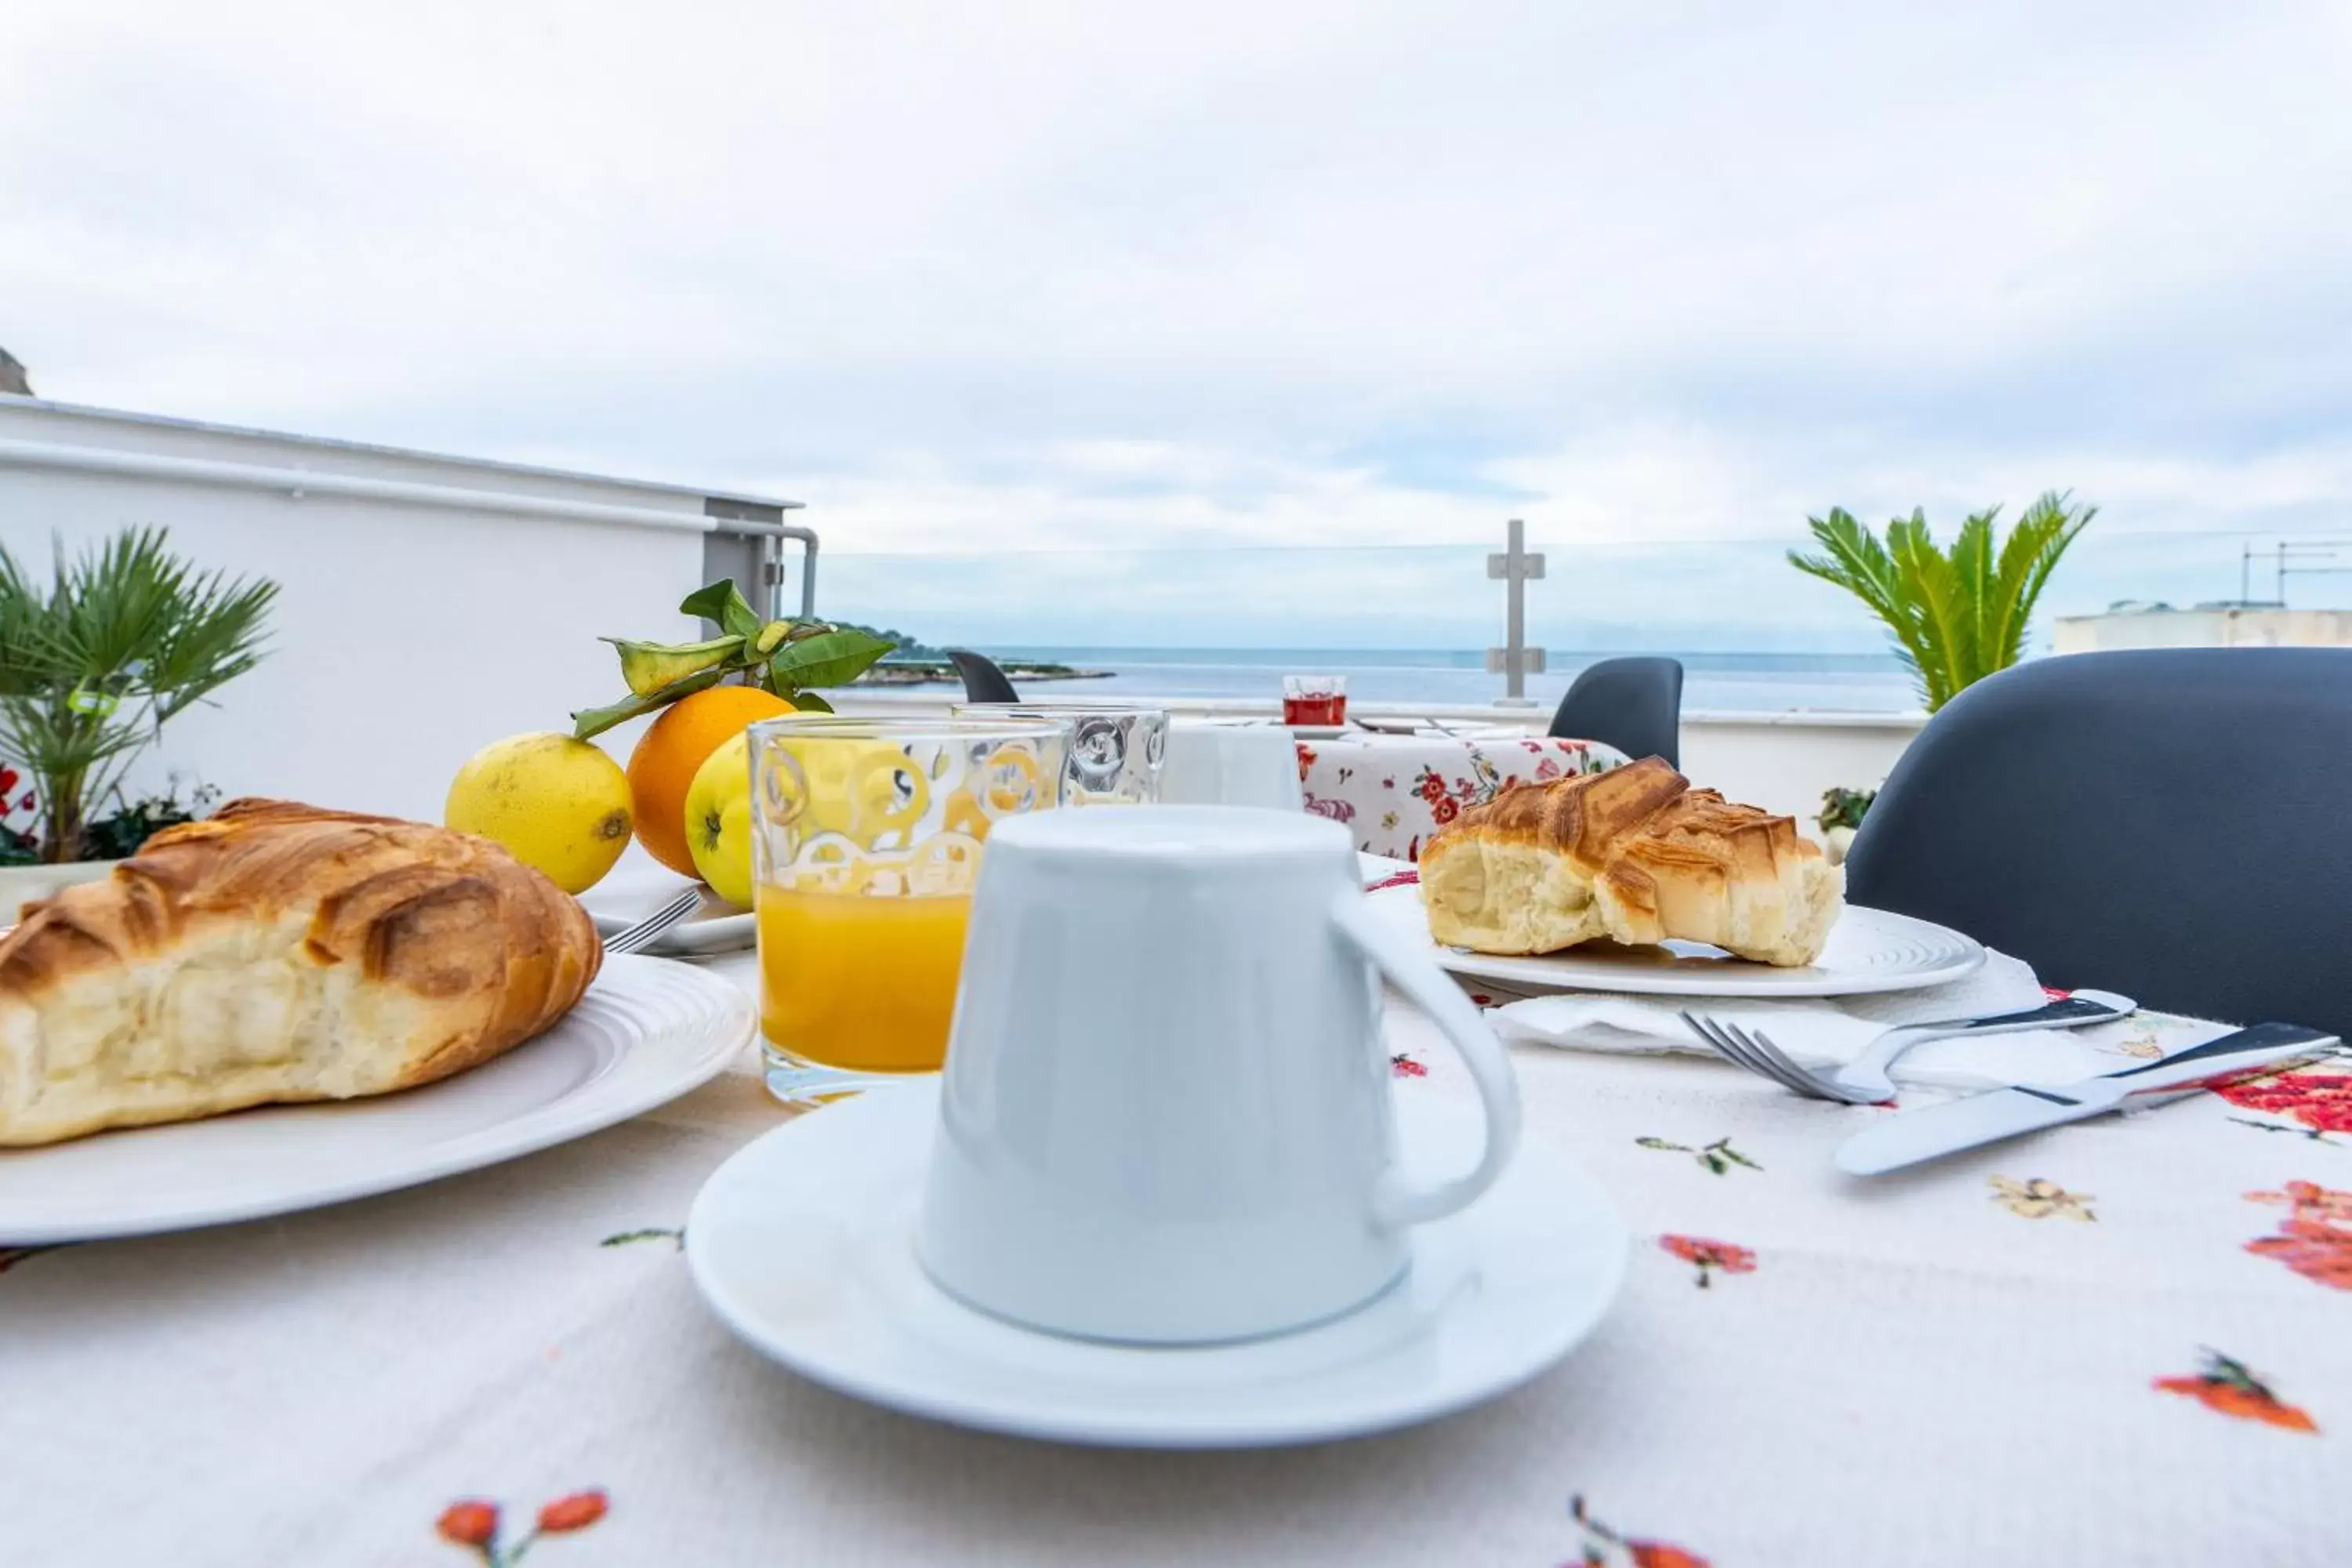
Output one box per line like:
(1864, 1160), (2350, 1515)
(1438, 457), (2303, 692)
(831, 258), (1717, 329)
(760, 884), (971, 1072)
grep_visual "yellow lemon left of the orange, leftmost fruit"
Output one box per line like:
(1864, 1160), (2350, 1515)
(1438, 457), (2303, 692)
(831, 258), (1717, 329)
(442, 731), (630, 893)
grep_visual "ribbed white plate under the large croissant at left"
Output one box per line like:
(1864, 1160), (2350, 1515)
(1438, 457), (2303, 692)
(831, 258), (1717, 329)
(0, 956), (757, 1246)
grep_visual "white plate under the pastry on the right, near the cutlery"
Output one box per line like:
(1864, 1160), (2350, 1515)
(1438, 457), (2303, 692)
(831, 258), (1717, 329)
(1374, 886), (1985, 996)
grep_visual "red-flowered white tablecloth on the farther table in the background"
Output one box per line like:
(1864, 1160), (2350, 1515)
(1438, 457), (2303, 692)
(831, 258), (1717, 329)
(1298, 731), (1628, 860)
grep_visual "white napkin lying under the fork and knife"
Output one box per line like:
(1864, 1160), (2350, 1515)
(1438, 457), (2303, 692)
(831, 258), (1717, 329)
(1472, 952), (2223, 1088)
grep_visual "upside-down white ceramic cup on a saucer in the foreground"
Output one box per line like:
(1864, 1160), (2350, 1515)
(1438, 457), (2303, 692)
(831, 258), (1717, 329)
(915, 806), (1519, 1345)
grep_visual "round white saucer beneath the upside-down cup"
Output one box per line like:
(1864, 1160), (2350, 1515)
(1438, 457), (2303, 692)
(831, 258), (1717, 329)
(687, 1083), (1628, 1448)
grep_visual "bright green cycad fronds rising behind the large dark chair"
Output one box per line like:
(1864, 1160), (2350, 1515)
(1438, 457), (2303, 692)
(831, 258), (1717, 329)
(1788, 492), (2098, 713)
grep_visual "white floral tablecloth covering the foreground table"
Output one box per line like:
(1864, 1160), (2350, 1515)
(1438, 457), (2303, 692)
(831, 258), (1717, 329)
(0, 959), (2352, 1568)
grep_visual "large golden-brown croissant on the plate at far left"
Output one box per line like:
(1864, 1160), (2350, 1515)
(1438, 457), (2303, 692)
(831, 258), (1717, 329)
(0, 799), (602, 1145)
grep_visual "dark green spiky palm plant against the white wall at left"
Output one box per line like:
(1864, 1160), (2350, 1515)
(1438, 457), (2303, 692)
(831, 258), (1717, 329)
(0, 529), (278, 862)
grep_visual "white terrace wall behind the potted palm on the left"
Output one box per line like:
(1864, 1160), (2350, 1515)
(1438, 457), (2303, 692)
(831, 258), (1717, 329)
(0, 397), (767, 820)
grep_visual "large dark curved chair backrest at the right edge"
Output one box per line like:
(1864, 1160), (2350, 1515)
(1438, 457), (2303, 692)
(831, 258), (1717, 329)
(1846, 649), (2352, 1036)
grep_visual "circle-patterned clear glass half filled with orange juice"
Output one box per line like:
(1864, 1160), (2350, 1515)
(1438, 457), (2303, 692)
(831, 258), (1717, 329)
(750, 715), (1068, 1105)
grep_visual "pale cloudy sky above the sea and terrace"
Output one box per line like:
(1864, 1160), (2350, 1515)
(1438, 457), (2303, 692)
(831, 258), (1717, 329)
(0, 0), (2352, 647)
